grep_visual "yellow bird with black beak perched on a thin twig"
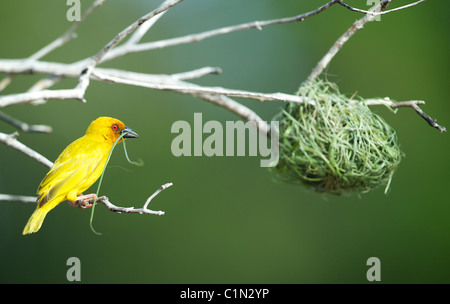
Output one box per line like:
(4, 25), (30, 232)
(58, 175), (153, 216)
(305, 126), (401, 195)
(23, 117), (138, 234)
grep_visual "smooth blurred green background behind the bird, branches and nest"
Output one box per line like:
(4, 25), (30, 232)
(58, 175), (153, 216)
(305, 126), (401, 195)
(0, 0), (450, 283)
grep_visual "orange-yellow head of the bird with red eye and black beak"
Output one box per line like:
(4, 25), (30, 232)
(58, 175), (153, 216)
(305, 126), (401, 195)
(86, 117), (138, 144)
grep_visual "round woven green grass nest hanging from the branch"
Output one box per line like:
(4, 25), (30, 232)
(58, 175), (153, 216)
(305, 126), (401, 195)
(272, 80), (402, 194)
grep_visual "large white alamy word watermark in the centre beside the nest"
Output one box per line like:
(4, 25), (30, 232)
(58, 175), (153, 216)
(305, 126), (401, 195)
(171, 113), (279, 167)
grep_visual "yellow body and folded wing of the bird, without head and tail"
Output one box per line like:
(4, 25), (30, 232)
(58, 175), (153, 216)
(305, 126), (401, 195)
(37, 138), (109, 206)
